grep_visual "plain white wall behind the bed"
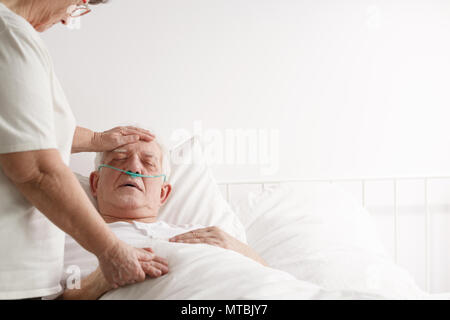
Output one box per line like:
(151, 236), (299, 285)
(43, 0), (450, 291)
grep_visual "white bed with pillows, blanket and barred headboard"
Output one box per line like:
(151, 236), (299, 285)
(78, 137), (450, 299)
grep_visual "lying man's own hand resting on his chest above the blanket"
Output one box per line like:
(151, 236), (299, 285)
(169, 227), (241, 252)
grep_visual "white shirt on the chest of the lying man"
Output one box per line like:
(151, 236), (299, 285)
(61, 221), (205, 286)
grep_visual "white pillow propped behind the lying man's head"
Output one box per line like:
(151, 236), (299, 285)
(75, 136), (246, 242)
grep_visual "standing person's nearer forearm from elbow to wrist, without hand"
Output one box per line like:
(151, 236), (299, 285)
(15, 154), (118, 256)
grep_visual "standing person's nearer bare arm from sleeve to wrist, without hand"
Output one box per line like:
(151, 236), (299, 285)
(0, 149), (117, 256)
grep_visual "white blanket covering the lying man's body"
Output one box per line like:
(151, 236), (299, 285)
(101, 240), (380, 300)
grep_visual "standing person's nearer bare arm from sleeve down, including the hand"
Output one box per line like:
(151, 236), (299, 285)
(0, 149), (158, 286)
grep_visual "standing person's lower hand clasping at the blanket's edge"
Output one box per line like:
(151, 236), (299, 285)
(98, 241), (169, 288)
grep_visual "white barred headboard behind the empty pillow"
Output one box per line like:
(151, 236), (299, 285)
(219, 176), (450, 299)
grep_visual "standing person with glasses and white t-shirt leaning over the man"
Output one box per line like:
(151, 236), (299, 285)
(0, 0), (168, 299)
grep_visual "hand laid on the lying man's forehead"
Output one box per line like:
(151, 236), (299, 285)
(92, 126), (155, 152)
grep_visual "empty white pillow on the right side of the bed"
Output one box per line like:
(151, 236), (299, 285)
(236, 184), (426, 299)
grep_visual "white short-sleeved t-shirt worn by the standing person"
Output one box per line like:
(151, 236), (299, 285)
(0, 3), (76, 299)
